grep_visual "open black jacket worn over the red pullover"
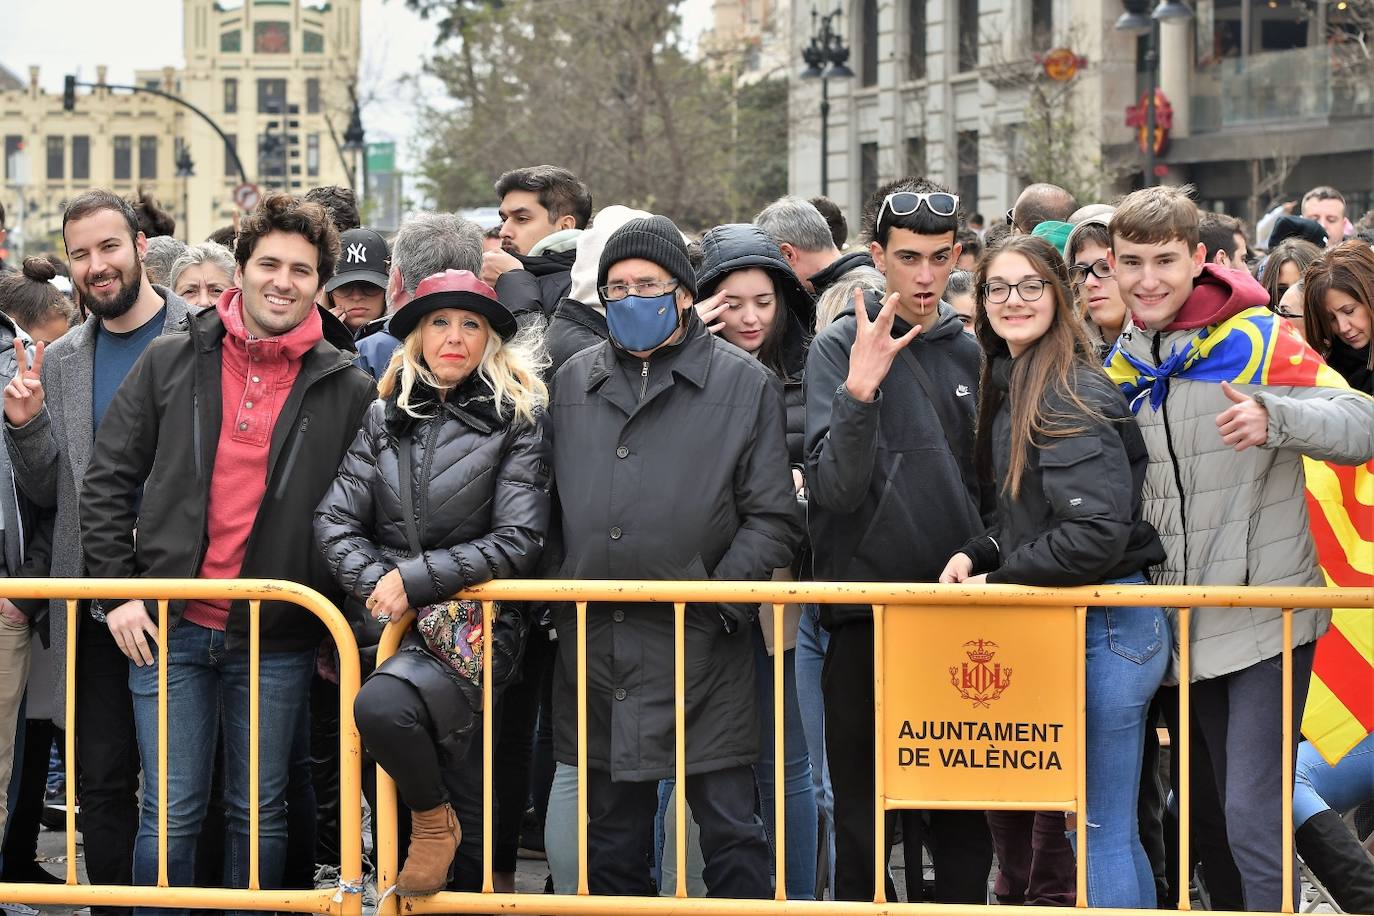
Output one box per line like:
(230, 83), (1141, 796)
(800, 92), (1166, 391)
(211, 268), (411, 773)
(81, 308), (376, 651)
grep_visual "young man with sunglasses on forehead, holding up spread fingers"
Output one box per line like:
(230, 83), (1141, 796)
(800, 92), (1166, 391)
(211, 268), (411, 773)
(805, 179), (993, 904)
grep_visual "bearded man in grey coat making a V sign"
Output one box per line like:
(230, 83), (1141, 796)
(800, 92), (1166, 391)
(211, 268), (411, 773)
(4, 190), (187, 916)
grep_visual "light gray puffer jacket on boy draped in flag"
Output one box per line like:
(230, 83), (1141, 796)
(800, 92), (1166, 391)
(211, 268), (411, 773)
(1121, 324), (1374, 681)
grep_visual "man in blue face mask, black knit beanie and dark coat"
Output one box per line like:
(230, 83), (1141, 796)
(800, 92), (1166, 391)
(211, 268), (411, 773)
(550, 216), (802, 898)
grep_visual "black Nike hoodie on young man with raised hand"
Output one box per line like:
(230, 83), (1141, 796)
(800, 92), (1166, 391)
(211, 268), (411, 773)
(805, 293), (995, 628)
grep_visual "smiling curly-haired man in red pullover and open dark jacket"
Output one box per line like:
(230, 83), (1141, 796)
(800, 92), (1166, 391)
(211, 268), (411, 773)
(80, 194), (375, 887)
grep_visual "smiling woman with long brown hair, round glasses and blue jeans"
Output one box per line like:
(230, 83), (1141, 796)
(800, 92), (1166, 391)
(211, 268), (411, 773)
(940, 236), (1169, 909)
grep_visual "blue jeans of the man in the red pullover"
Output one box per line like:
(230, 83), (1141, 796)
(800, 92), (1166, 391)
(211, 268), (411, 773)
(129, 621), (315, 912)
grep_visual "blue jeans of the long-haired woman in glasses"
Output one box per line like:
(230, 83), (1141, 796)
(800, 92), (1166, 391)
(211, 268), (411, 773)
(1087, 575), (1171, 909)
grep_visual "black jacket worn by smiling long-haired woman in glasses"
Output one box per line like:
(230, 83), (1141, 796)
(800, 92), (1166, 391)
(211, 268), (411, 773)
(965, 357), (1164, 586)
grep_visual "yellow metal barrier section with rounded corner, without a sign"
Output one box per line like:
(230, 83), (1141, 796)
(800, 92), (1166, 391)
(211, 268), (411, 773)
(0, 578), (363, 916)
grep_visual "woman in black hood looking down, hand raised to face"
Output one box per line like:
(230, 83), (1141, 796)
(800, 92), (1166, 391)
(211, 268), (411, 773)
(697, 222), (820, 900)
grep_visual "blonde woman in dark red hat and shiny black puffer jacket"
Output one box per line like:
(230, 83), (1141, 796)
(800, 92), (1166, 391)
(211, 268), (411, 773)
(315, 271), (550, 895)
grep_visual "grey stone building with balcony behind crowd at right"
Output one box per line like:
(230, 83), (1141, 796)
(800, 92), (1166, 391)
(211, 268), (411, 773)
(789, 0), (1374, 240)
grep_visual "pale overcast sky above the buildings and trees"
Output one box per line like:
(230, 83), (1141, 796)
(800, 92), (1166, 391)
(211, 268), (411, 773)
(0, 0), (710, 175)
